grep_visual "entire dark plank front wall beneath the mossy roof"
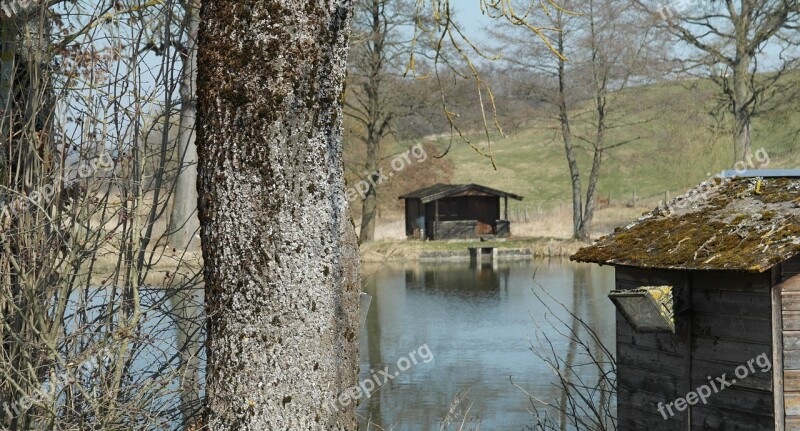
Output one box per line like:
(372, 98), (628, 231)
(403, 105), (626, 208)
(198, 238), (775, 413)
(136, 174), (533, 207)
(616, 267), (774, 431)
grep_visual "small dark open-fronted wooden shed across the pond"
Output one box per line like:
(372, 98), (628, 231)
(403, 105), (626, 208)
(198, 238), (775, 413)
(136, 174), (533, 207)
(400, 184), (522, 240)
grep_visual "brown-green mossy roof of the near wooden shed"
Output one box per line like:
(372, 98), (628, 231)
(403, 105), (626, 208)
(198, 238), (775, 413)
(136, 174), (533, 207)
(570, 177), (800, 272)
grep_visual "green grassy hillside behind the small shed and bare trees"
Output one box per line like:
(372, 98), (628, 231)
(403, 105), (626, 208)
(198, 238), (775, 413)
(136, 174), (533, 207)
(384, 76), (800, 216)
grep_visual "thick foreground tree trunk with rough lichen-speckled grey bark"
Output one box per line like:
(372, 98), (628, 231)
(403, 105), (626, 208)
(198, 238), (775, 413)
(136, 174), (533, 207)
(197, 0), (360, 431)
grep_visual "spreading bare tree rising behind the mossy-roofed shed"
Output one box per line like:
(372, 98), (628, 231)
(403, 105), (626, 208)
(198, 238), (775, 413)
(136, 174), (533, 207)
(634, 0), (800, 161)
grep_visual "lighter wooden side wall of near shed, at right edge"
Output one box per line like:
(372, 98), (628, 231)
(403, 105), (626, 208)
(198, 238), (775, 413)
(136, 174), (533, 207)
(780, 256), (800, 430)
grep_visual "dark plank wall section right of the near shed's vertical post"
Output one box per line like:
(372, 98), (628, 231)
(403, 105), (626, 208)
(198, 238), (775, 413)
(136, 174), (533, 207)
(690, 271), (775, 430)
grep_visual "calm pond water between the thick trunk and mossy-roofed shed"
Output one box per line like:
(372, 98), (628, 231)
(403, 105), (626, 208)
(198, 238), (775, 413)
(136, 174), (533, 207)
(358, 259), (614, 431)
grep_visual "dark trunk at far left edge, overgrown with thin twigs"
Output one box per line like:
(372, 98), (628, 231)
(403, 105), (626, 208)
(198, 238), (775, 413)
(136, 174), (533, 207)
(0, 2), (54, 430)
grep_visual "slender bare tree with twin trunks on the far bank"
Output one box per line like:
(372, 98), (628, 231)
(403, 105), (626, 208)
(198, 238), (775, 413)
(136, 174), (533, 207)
(494, 0), (663, 240)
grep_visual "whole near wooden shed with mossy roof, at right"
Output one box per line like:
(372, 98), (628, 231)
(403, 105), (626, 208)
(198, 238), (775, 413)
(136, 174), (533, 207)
(571, 171), (800, 431)
